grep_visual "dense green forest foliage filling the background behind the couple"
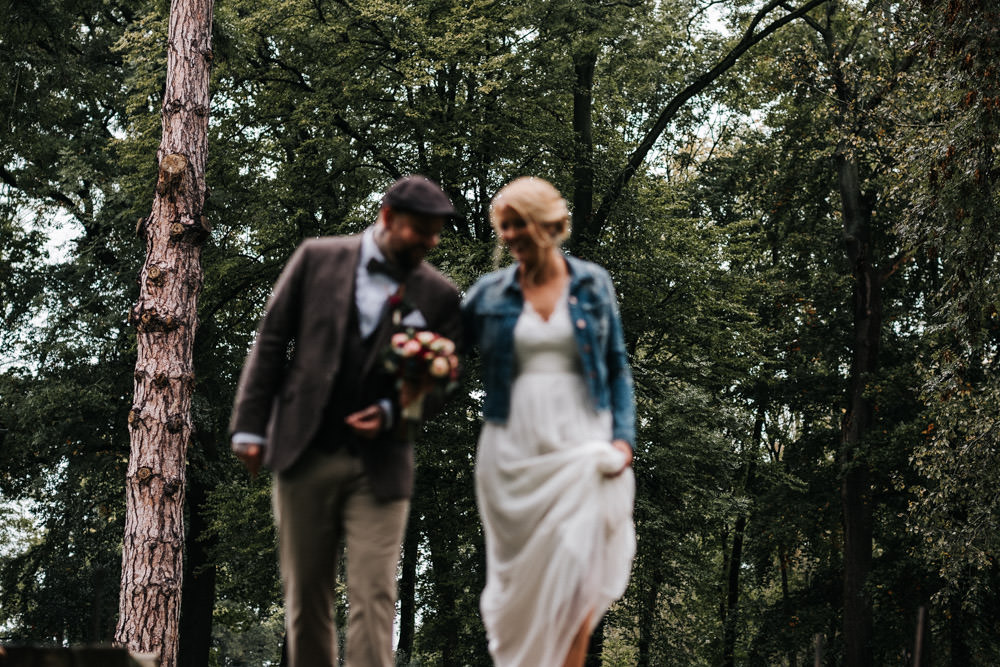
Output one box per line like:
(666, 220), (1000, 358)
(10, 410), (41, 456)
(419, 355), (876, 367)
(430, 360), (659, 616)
(0, 0), (1000, 665)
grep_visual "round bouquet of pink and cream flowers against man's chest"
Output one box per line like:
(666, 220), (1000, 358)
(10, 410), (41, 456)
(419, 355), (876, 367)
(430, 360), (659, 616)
(385, 330), (458, 421)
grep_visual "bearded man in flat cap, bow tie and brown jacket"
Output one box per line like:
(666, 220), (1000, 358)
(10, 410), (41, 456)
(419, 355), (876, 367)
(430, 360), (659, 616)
(230, 176), (461, 667)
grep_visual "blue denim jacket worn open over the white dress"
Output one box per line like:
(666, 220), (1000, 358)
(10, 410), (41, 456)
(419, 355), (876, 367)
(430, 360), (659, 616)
(462, 255), (635, 446)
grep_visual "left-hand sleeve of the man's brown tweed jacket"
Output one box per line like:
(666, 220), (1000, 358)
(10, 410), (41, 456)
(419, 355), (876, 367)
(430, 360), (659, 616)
(229, 244), (308, 435)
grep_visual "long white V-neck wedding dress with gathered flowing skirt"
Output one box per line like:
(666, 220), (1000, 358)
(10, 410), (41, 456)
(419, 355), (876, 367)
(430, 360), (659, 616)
(476, 294), (635, 667)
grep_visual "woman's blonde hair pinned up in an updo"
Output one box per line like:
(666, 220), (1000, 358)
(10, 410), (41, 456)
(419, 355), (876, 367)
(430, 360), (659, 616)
(490, 176), (569, 278)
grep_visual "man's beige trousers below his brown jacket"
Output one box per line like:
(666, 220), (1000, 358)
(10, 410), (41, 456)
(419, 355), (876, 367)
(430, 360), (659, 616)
(272, 447), (410, 667)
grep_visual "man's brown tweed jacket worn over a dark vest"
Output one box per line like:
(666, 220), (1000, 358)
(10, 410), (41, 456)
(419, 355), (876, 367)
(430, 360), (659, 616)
(229, 236), (461, 500)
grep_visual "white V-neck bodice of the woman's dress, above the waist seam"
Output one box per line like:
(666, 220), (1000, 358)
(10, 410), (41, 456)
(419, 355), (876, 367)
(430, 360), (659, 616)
(514, 293), (582, 375)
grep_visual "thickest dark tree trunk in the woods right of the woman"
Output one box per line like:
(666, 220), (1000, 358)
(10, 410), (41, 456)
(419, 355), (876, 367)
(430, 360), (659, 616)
(837, 147), (882, 667)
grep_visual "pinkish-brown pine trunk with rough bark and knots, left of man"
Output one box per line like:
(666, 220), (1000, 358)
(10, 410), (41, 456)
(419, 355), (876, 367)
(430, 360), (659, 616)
(115, 0), (213, 667)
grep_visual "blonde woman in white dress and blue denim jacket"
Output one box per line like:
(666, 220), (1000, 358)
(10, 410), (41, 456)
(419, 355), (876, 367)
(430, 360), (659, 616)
(463, 178), (635, 667)
